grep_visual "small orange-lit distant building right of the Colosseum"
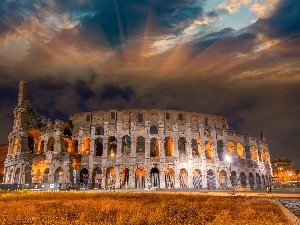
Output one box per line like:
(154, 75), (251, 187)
(272, 157), (297, 184)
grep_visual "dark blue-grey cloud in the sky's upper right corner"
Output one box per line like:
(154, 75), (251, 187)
(254, 0), (300, 37)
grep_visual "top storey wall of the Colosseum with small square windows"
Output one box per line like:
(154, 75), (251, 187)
(70, 109), (229, 134)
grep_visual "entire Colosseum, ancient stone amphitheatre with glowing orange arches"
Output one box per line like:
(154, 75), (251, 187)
(3, 81), (272, 189)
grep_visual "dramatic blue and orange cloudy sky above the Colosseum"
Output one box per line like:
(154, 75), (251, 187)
(0, 0), (300, 168)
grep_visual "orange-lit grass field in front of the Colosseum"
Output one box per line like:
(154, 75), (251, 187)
(0, 191), (289, 225)
